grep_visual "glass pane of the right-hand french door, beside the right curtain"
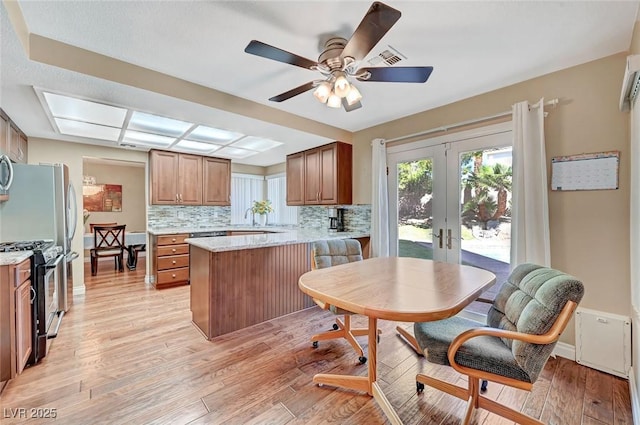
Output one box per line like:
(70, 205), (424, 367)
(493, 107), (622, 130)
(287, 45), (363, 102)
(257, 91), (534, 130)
(460, 146), (512, 313)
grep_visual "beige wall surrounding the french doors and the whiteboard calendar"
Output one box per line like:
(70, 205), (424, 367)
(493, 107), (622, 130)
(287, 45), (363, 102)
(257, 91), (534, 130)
(353, 53), (630, 344)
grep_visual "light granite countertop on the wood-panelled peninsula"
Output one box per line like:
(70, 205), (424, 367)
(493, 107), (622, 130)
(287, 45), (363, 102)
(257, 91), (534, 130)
(186, 228), (369, 252)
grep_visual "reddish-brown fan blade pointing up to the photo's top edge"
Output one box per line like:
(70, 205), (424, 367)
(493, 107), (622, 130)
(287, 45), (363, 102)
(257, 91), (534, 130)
(340, 1), (401, 61)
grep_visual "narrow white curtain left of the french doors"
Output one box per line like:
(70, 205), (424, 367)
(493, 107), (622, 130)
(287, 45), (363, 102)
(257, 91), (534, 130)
(371, 139), (389, 257)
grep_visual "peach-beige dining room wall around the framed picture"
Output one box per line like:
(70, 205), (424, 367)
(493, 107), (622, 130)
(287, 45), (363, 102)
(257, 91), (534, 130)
(82, 162), (147, 232)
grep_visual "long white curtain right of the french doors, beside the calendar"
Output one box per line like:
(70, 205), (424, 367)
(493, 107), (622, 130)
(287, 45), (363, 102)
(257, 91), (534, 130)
(511, 99), (551, 268)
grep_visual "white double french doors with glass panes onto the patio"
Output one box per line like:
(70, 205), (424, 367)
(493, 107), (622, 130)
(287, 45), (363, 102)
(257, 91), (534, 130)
(387, 123), (512, 310)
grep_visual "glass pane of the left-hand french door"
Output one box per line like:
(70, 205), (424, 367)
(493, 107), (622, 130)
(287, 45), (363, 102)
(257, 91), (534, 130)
(397, 158), (433, 259)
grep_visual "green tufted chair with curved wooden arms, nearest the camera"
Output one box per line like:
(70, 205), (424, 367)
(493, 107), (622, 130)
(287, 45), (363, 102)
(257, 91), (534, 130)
(404, 264), (584, 425)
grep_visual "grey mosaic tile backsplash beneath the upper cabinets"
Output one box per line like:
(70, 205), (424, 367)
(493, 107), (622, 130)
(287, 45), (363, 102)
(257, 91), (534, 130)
(147, 205), (371, 232)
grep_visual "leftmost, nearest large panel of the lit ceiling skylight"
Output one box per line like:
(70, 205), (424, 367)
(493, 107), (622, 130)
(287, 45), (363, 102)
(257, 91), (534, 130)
(42, 92), (127, 127)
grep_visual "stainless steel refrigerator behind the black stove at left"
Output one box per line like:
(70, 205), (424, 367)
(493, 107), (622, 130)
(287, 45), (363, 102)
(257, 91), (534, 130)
(0, 164), (79, 311)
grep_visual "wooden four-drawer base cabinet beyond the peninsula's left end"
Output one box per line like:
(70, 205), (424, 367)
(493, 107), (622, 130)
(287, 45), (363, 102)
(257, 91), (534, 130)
(151, 233), (189, 289)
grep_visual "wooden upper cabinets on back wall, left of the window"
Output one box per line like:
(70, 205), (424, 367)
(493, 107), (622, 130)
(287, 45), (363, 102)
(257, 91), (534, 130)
(149, 150), (231, 205)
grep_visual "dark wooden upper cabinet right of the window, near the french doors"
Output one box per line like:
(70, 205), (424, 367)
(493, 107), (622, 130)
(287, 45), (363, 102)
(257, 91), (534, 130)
(287, 142), (353, 205)
